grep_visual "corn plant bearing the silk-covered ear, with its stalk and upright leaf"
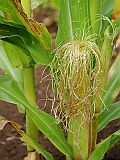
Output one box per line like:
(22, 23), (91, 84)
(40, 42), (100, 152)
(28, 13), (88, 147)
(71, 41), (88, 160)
(51, 0), (119, 160)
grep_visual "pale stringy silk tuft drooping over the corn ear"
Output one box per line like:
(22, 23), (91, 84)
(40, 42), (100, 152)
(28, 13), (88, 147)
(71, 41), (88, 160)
(51, 40), (104, 128)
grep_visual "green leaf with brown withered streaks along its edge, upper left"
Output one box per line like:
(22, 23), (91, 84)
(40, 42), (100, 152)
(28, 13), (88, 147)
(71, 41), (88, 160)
(0, 0), (50, 41)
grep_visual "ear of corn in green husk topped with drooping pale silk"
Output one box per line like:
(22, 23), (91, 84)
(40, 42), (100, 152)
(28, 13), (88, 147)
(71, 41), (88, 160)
(51, 38), (104, 159)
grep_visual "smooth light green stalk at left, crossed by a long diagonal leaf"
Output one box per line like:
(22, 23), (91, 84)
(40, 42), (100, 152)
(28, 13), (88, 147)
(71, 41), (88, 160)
(21, 0), (38, 151)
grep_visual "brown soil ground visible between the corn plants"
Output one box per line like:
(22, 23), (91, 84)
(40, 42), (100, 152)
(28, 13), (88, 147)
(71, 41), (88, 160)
(0, 6), (120, 160)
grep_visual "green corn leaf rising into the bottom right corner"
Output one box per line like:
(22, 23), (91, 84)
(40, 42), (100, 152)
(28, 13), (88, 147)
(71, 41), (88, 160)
(88, 130), (120, 160)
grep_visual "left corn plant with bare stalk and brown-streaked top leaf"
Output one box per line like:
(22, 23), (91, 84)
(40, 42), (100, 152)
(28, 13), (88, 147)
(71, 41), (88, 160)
(0, 0), (70, 159)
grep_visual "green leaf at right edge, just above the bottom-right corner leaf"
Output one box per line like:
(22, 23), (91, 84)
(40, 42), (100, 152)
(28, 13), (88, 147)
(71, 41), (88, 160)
(98, 102), (120, 132)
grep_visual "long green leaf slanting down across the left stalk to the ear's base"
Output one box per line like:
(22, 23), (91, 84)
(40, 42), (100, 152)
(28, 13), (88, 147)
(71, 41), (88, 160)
(0, 77), (72, 156)
